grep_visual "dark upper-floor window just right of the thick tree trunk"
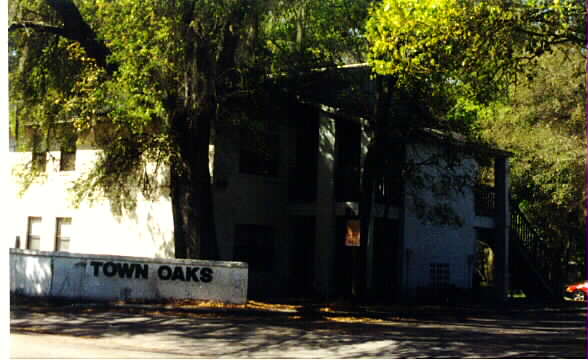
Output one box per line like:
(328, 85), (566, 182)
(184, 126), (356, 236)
(239, 121), (280, 176)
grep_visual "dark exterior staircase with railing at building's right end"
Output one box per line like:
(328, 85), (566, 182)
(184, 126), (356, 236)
(509, 204), (562, 301)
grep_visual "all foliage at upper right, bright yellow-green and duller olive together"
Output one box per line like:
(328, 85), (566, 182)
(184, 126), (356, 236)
(366, 0), (586, 239)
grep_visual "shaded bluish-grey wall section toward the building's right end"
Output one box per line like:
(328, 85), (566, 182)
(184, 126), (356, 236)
(402, 145), (478, 295)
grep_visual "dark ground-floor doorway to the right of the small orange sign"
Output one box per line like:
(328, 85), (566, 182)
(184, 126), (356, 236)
(372, 218), (401, 301)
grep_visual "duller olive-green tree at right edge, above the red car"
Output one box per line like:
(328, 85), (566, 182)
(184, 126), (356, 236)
(478, 47), (587, 262)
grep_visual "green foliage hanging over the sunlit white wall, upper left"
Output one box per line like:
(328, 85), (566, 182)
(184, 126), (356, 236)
(10, 1), (178, 208)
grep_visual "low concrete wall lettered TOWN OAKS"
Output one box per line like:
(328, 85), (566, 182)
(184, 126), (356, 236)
(10, 249), (248, 304)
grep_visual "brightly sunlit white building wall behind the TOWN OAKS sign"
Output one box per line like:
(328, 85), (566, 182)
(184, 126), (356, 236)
(8, 150), (174, 258)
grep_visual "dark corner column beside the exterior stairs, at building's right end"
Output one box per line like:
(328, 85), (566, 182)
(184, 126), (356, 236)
(494, 157), (510, 301)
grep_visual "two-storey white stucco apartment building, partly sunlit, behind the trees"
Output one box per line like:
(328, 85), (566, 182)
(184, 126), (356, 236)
(5, 96), (509, 299)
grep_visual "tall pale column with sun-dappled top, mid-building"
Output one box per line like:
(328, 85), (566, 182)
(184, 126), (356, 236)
(314, 112), (336, 296)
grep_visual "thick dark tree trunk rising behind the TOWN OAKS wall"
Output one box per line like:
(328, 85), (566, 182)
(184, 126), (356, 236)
(170, 104), (218, 259)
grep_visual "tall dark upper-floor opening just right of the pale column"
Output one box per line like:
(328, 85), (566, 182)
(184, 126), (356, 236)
(335, 119), (361, 201)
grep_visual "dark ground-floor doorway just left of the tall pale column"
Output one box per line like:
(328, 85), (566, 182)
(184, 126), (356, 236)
(288, 216), (316, 296)
